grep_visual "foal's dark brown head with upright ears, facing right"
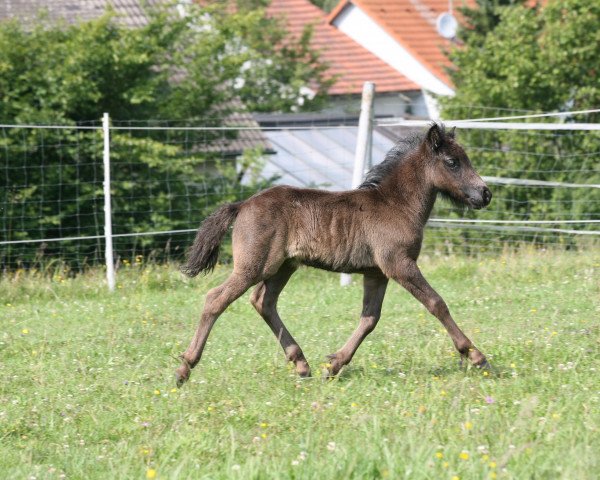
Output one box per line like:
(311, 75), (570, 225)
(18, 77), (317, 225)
(423, 123), (492, 209)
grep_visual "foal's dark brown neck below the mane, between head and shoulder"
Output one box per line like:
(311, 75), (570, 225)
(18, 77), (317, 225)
(385, 151), (437, 227)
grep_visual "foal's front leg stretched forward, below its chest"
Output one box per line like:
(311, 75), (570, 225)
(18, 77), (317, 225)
(391, 259), (488, 368)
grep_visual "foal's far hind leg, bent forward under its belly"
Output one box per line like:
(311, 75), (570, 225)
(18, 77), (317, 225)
(250, 262), (310, 377)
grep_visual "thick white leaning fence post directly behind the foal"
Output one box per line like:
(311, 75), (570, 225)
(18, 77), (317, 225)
(340, 82), (375, 286)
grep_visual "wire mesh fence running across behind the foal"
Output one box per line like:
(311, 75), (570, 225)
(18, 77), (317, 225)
(0, 116), (600, 271)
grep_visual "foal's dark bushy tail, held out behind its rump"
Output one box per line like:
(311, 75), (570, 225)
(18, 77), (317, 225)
(181, 202), (243, 277)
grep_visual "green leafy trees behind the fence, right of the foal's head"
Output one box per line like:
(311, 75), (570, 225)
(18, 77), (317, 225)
(440, 0), (600, 240)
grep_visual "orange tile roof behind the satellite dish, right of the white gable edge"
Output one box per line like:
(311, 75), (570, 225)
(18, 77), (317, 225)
(328, 0), (473, 85)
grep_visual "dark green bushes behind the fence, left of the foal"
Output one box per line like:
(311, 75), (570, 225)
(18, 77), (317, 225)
(0, 2), (329, 265)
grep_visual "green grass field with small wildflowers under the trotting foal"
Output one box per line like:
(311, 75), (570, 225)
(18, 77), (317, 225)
(0, 250), (600, 479)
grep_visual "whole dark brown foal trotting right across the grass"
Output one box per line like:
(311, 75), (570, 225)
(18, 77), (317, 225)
(176, 124), (492, 384)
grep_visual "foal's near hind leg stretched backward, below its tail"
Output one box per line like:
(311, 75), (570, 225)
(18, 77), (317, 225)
(175, 271), (254, 386)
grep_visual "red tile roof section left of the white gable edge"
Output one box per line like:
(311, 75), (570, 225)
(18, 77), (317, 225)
(268, 0), (420, 95)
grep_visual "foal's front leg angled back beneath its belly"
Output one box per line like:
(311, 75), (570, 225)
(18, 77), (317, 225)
(327, 275), (388, 376)
